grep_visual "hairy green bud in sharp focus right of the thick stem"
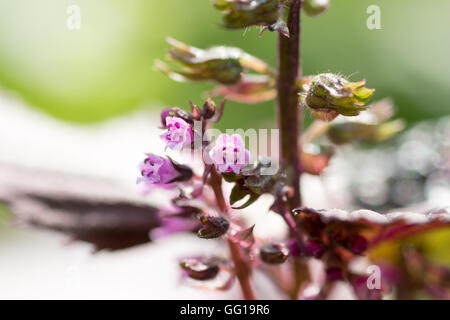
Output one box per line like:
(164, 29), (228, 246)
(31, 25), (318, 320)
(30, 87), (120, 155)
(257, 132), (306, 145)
(301, 73), (375, 121)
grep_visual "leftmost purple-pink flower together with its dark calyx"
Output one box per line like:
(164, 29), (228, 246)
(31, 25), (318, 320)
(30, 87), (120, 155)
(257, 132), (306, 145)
(137, 153), (193, 184)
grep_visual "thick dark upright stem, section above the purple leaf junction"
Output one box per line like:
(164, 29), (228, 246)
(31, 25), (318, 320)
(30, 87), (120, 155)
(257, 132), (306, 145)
(277, 0), (301, 210)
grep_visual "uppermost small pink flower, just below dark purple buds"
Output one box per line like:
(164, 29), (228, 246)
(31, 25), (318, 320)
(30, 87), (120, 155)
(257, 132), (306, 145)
(161, 116), (193, 150)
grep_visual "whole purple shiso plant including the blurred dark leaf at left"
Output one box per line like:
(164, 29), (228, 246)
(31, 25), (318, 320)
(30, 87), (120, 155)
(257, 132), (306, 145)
(5, 0), (450, 299)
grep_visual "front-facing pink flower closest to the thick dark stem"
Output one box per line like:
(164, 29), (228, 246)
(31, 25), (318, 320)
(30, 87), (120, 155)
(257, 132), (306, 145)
(209, 134), (250, 174)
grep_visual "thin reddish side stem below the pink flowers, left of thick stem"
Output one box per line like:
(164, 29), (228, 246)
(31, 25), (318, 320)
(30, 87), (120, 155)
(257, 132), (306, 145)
(209, 167), (256, 300)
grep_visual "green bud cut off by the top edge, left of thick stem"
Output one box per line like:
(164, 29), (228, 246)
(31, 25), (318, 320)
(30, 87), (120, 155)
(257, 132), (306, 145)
(214, 0), (280, 29)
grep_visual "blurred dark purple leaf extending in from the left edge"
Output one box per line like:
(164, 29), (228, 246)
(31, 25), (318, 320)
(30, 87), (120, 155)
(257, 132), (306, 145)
(0, 164), (168, 250)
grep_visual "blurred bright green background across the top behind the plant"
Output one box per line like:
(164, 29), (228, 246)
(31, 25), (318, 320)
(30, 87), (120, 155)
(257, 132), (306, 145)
(0, 0), (450, 128)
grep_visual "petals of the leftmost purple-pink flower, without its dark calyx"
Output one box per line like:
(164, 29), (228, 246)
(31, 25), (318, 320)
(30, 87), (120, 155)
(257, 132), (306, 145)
(137, 153), (181, 184)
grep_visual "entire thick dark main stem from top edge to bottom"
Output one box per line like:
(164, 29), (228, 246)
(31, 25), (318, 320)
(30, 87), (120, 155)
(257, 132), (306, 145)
(277, 0), (309, 299)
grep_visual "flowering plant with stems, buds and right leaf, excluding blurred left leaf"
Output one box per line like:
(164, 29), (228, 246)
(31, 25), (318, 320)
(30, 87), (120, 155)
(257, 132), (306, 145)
(139, 0), (450, 299)
